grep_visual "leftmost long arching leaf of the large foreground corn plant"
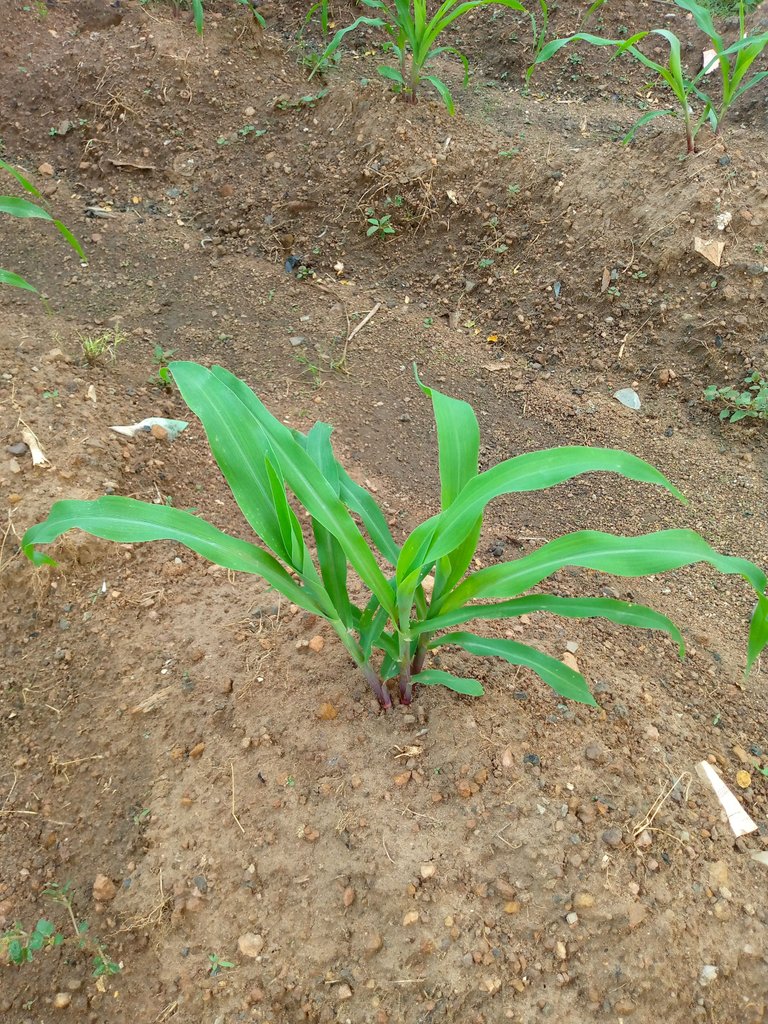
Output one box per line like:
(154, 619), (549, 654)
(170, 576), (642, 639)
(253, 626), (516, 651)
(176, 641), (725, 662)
(22, 495), (326, 615)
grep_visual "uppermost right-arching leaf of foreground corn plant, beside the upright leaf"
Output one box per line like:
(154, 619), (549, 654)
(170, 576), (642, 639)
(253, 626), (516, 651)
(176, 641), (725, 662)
(397, 446), (685, 596)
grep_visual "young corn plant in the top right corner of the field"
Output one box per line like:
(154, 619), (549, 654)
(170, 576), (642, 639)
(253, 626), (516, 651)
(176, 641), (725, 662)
(528, 0), (768, 153)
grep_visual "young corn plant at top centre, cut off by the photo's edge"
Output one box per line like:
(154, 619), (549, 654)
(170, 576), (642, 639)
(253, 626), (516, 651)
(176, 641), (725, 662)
(309, 0), (527, 114)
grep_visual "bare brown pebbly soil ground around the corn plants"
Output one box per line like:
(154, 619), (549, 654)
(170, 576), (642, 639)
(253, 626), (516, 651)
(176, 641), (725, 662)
(0, 0), (768, 1024)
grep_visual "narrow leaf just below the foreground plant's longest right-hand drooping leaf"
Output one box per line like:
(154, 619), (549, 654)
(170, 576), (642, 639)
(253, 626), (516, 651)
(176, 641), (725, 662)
(411, 594), (685, 656)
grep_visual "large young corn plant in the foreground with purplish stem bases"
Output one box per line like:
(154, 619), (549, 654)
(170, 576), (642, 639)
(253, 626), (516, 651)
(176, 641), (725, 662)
(22, 362), (768, 709)
